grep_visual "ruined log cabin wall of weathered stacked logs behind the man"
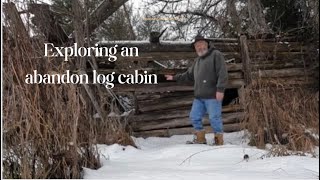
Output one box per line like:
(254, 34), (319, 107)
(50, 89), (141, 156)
(98, 35), (318, 137)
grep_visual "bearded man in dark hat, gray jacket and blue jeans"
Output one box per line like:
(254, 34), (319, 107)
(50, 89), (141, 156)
(165, 35), (228, 145)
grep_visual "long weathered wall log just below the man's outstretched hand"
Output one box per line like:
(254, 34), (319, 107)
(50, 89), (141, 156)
(113, 79), (244, 93)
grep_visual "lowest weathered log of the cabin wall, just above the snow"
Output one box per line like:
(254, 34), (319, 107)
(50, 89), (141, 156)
(133, 123), (241, 138)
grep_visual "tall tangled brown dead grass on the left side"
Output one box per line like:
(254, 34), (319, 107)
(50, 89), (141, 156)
(3, 10), (133, 179)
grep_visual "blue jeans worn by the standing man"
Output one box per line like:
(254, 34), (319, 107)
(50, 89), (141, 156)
(190, 99), (223, 133)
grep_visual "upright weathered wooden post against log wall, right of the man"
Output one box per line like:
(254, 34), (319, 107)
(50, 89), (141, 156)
(240, 35), (251, 85)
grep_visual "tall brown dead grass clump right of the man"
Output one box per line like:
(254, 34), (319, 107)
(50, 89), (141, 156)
(243, 79), (319, 155)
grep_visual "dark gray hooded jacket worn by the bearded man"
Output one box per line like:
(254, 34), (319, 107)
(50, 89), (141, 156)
(173, 48), (228, 99)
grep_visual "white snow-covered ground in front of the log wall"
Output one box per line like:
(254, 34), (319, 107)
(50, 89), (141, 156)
(84, 132), (319, 180)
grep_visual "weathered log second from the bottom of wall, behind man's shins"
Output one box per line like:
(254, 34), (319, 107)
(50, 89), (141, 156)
(131, 112), (244, 132)
